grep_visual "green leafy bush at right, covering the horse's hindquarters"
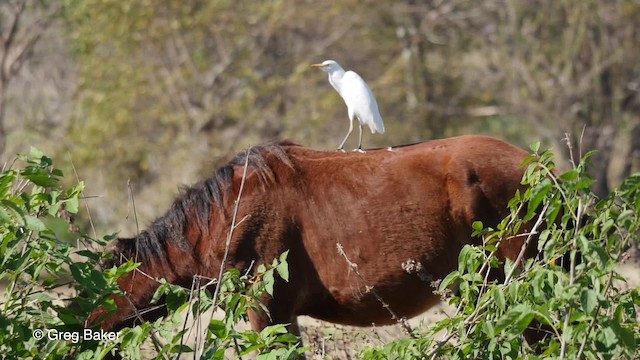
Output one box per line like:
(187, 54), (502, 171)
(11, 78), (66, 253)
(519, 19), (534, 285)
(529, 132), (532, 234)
(362, 145), (640, 359)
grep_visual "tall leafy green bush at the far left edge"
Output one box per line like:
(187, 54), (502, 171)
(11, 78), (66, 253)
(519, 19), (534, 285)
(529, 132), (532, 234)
(0, 150), (115, 359)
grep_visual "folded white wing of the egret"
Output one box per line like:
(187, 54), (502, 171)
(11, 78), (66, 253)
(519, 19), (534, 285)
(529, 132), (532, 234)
(340, 71), (384, 134)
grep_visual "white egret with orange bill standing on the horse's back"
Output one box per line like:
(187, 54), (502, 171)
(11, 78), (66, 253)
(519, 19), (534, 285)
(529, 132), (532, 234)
(311, 60), (384, 152)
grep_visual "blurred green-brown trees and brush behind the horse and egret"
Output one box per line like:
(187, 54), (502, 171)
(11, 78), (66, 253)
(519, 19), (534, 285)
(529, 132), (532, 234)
(0, 0), (640, 235)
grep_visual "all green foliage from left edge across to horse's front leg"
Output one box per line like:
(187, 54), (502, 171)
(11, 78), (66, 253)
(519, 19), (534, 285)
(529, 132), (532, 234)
(0, 150), (304, 359)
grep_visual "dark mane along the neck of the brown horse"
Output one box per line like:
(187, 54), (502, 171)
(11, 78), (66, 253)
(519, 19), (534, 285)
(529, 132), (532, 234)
(116, 141), (297, 263)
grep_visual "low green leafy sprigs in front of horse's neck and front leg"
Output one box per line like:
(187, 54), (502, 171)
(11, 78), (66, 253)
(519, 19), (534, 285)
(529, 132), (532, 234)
(135, 252), (305, 359)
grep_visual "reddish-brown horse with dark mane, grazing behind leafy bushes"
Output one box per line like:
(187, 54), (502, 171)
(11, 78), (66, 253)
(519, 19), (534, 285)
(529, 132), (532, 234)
(92, 136), (535, 331)
